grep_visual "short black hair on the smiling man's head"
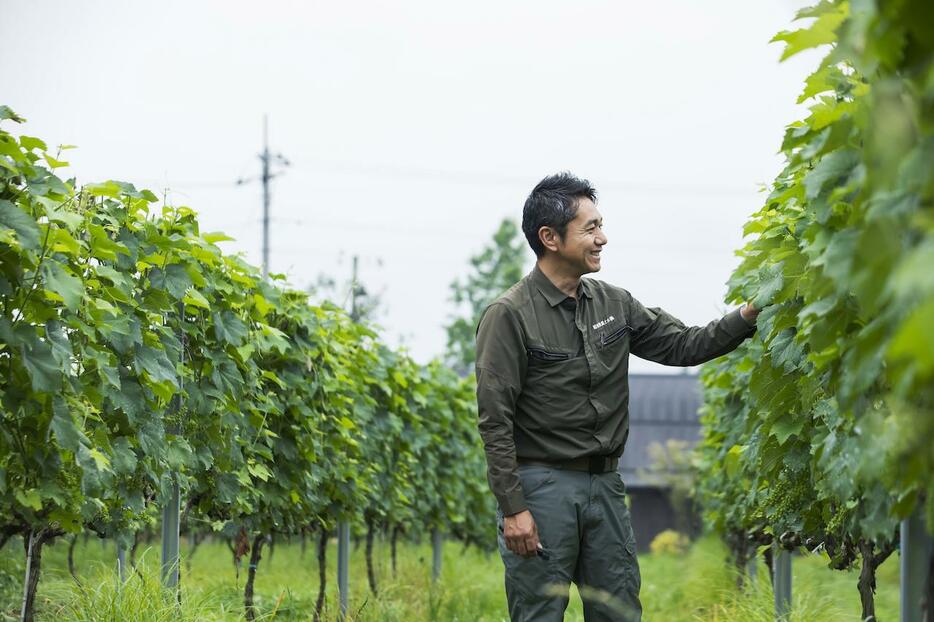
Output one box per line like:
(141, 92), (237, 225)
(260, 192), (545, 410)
(522, 171), (597, 257)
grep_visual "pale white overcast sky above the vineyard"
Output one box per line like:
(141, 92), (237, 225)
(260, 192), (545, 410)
(0, 0), (817, 371)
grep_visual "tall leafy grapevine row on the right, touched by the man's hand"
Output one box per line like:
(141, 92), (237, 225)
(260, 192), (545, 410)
(698, 0), (934, 618)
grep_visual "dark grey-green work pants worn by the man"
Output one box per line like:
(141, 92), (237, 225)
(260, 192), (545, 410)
(497, 465), (642, 622)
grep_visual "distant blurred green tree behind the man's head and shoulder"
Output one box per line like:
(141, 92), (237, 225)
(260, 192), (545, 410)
(445, 218), (528, 376)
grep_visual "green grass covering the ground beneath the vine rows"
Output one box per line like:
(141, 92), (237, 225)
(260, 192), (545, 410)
(0, 538), (898, 622)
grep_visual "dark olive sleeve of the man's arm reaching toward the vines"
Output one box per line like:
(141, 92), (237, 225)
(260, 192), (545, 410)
(628, 297), (756, 366)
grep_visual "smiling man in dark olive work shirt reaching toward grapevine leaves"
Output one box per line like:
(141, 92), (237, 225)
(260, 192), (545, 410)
(477, 173), (758, 622)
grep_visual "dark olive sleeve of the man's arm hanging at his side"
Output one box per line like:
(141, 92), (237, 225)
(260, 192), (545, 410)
(477, 303), (528, 516)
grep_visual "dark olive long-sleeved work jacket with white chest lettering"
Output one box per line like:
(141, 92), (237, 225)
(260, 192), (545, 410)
(477, 265), (755, 516)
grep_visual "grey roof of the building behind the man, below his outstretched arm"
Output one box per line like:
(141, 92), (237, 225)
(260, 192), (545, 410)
(619, 374), (701, 486)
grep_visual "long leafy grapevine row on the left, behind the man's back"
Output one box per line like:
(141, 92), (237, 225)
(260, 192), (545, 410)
(0, 106), (493, 616)
